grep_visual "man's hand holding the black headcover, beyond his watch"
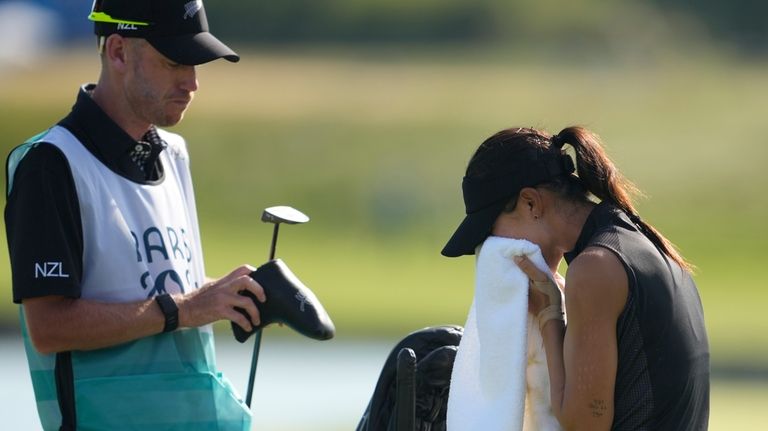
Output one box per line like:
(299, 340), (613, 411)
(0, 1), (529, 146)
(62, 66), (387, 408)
(174, 265), (267, 331)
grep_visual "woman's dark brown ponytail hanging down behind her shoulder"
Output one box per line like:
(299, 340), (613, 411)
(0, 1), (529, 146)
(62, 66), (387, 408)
(551, 127), (693, 272)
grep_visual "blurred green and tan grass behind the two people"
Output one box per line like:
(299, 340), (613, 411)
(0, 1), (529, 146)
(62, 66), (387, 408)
(0, 51), (768, 374)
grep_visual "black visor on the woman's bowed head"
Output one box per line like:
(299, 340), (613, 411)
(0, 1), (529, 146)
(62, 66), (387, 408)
(442, 150), (576, 257)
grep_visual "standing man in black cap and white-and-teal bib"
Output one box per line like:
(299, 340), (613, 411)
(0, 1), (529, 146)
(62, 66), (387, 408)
(5, 0), (266, 430)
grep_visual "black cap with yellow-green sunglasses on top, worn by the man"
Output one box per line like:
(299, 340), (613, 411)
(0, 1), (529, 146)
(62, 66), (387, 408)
(88, 0), (240, 66)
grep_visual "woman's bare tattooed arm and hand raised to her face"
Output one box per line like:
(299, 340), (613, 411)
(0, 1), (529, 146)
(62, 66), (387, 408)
(519, 248), (628, 431)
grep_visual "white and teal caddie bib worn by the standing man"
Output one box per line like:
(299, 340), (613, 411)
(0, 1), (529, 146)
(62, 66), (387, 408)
(8, 126), (251, 431)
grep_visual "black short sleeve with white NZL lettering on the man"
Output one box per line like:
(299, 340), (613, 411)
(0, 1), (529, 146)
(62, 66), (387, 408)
(5, 143), (83, 304)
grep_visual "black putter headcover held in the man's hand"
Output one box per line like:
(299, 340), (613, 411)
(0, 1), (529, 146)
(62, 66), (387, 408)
(232, 259), (336, 343)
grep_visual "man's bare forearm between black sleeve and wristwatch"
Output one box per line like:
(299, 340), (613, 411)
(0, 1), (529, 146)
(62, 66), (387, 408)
(24, 297), (165, 354)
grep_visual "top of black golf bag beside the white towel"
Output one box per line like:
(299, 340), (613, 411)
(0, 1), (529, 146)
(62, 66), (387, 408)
(356, 326), (464, 431)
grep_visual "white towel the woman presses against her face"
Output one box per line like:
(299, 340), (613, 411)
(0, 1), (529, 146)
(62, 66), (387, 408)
(447, 236), (561, 431)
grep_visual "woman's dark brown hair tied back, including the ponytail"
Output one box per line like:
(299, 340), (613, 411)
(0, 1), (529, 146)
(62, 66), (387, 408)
(466, 126), (693, 272)
